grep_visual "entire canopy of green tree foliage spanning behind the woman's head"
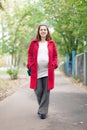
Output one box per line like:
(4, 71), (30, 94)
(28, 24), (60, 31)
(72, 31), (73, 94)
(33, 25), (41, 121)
(0, 0), (87, 66)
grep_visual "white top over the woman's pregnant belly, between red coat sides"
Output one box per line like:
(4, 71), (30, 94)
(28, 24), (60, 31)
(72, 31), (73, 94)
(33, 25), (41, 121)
(37, 41), (48, 78)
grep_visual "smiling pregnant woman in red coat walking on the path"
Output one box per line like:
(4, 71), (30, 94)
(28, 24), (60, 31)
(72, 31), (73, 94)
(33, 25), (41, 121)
(27, 25), (58, 119)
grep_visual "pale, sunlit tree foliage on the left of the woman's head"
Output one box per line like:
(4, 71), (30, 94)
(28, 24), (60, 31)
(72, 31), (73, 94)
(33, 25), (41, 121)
(0, 1), (44, 66)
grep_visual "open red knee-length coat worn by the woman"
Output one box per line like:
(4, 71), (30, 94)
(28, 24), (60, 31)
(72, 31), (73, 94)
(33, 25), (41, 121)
(27, 40), (58, 90)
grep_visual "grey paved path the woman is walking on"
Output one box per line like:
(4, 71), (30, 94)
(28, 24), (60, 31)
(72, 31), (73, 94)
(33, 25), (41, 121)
(0, 71), (87, 130)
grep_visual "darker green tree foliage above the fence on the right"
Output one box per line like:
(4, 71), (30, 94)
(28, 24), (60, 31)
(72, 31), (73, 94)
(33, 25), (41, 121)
(43, 0), (87, 55)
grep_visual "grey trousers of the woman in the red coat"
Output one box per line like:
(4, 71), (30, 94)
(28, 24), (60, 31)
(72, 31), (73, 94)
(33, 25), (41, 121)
(35, 77), (50, 114)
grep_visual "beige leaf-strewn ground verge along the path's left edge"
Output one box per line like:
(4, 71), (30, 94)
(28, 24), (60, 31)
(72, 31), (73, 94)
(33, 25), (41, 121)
(0, 79), (28, 101)
